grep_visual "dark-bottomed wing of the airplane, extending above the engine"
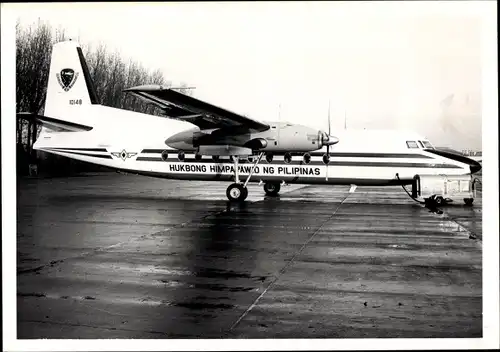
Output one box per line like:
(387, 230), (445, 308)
(124, 85), (269, 132)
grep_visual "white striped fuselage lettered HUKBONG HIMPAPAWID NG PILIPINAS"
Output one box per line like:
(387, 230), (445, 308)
(35, 105), (471, 185)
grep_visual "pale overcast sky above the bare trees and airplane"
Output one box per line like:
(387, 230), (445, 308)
(5, 2), (494, 149)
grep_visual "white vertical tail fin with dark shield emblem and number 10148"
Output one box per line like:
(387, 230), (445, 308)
(44, 41), (98, 119)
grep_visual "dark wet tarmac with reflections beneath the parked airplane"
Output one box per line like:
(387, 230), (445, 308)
(17, 173), (482, 339)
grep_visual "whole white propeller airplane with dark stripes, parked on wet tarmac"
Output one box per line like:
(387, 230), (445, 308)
(18, 40), (481, 202)
